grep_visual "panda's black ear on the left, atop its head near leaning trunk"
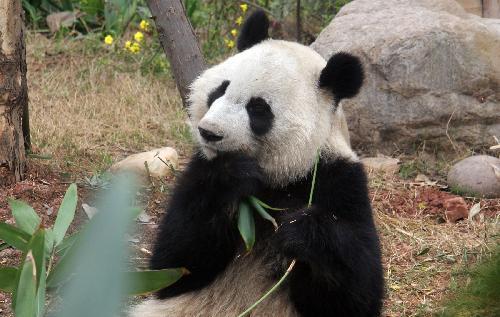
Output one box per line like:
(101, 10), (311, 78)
(238, 10), (269, 52)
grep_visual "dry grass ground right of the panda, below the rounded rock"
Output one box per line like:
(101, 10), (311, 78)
(370, 175), (500, 316)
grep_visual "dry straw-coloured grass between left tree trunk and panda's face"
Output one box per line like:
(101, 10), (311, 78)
(27, 35), (190, 172)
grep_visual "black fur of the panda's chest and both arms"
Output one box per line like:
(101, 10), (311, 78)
(152, 154), (383, 317)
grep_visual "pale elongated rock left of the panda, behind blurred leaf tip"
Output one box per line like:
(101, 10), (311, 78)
(110, 147), (179, 178)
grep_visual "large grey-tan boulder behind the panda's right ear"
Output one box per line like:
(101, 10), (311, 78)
(312, 0), (500, 154)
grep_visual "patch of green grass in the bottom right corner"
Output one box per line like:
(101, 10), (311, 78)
(436, 247), (500, 317)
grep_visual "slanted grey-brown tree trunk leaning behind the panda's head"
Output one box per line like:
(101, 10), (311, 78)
(147, 0), (205, 106)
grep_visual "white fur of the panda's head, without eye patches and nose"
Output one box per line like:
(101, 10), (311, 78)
(189, 40), (357, 186)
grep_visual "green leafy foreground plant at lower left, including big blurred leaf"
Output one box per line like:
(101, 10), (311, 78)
(0, 179), (188, 317)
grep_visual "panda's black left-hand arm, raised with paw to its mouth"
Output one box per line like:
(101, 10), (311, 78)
(151, 154), (260, 298)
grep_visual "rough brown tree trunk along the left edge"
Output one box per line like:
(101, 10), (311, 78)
(0, 0), (28, 185)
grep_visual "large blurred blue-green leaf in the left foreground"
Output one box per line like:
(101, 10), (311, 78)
(51, 176), (136, 317)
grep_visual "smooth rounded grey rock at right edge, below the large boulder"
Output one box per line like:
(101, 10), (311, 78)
(448, 155), (500, 198)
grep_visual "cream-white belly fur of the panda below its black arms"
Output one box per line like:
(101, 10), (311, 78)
(130, 254), (298, 317)
